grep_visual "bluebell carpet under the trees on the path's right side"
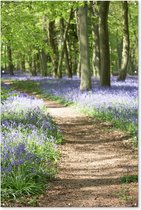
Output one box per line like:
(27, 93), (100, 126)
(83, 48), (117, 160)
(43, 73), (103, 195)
(41, 76), (138, 135)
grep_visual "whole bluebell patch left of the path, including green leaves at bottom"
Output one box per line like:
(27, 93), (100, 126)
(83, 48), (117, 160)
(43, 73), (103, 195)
(1, 85), (62, 199)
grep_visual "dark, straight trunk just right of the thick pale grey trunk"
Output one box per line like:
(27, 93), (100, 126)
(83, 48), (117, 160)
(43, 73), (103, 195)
(99, 1), (110, 86)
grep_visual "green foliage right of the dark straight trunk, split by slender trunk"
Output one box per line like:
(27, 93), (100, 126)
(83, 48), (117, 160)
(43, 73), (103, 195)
(108, 1), (138, 74)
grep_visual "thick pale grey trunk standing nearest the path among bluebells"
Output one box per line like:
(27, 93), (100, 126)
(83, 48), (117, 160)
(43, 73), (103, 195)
(79, 2), (92, 91)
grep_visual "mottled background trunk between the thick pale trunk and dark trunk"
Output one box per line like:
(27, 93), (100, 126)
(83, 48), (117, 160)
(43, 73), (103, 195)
(90, 1), (100, 77)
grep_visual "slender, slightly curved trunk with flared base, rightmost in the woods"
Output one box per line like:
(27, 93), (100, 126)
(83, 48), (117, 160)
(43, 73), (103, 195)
(118, 1), (129, 81)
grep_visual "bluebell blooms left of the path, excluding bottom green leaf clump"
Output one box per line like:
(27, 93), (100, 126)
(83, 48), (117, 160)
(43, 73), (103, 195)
(1, 88), (61, 180)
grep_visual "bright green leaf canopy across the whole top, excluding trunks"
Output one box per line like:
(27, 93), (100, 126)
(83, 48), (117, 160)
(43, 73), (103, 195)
(1, 1), (138, 75)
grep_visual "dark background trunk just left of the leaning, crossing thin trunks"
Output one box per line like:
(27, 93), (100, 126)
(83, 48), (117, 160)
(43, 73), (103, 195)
(48, 21), (59, 78)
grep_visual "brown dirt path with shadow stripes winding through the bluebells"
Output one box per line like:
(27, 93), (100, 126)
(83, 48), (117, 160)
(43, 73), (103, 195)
(39, 102), (138, 207)
